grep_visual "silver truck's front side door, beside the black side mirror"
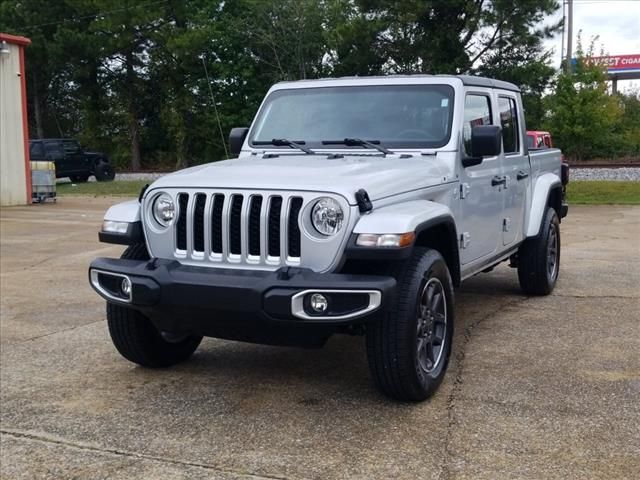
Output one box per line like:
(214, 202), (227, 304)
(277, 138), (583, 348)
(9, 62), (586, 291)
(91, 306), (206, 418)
(458, 93), (503, 268)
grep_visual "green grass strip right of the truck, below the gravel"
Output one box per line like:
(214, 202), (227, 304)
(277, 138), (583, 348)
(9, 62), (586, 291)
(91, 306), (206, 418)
(567, 181), (640, 205)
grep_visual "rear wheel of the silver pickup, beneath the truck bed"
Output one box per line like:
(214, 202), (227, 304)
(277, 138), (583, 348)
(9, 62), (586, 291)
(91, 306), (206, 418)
(518, 207), (560, 295)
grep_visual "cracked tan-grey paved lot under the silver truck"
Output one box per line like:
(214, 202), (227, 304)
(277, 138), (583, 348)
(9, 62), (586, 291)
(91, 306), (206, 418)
(0, 197), (640, 480)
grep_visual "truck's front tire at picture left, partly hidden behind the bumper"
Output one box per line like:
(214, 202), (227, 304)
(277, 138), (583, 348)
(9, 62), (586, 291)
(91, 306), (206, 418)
(107, 244), (202, 368)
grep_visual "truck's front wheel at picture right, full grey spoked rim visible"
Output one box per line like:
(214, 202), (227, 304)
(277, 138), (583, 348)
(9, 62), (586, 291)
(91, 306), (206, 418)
(366, 247), (454, 401)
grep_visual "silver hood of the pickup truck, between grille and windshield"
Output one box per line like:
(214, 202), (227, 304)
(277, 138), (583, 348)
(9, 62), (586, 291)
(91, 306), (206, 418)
(152, 155), (451, 204)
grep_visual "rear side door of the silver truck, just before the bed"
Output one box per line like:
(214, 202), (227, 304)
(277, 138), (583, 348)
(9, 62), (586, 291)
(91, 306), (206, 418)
(498, 92), (531, 246)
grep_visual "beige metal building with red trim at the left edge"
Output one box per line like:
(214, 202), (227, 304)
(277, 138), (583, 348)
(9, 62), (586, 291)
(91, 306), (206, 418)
(0, 33), (31, 206)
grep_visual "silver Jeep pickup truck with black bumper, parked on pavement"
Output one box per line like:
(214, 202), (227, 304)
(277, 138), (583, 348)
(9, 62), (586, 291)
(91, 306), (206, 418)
(89, 75), (568, 401)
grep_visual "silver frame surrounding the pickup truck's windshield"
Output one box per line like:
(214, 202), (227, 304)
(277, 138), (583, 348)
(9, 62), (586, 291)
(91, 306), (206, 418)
(247, 82), (457, 151)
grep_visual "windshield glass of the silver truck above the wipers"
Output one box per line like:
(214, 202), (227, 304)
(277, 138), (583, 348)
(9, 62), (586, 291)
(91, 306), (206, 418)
(249, 85), (453, 148)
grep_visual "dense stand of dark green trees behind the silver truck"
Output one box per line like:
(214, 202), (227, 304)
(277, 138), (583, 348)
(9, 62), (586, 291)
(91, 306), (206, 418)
(0, 0), (576, 169)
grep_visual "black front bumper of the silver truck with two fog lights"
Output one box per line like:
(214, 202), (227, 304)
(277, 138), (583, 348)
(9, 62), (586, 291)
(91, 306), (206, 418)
(89, 258), (396, 345)
